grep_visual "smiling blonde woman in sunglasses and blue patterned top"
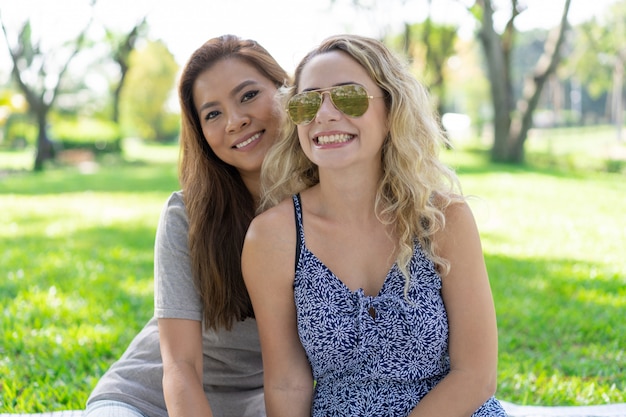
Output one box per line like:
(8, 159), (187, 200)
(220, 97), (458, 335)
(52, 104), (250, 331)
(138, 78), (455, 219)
(242, 35), (506, 417)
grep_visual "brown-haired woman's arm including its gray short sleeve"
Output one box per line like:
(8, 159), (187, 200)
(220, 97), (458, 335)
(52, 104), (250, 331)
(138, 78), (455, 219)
(154, 193), (212, 417)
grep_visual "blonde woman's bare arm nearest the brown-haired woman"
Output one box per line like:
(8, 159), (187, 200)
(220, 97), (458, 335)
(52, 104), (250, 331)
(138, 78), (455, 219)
(242, 204), (313, 417)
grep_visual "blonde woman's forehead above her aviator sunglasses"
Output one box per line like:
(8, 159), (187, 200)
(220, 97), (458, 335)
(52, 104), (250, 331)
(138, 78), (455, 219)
(298, 51), (375, 91)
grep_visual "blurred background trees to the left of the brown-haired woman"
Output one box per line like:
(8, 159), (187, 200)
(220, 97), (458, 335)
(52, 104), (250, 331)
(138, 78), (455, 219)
(0, 0), (179, 171)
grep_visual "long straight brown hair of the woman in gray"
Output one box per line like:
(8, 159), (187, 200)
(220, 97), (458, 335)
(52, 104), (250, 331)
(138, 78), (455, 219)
(178, 35), (289, 329)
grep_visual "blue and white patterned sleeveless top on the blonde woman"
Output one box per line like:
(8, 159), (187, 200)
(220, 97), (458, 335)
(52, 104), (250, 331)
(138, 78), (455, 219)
(293, 195), (506, 417)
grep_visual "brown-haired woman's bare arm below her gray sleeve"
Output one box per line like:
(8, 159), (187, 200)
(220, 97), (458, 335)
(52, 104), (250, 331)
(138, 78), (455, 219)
(159, 319), (213, 417)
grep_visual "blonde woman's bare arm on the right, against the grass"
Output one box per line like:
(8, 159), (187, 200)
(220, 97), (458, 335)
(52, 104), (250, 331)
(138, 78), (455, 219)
(410, 203), (498, 417)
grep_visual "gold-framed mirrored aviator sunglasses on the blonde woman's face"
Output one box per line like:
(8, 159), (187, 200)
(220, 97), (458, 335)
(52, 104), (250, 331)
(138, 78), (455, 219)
(287, 84), (380, 125)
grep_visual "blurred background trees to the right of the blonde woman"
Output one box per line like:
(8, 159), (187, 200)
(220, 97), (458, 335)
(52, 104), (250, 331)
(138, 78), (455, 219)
(356, 0), (626, 163)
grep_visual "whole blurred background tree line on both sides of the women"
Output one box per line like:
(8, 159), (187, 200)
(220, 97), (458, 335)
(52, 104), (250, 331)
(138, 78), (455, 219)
(0, 0), (626, 170)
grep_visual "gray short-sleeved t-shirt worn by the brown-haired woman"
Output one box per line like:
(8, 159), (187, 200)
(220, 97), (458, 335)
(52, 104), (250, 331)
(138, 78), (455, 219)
(87, 191), (265, 417)
